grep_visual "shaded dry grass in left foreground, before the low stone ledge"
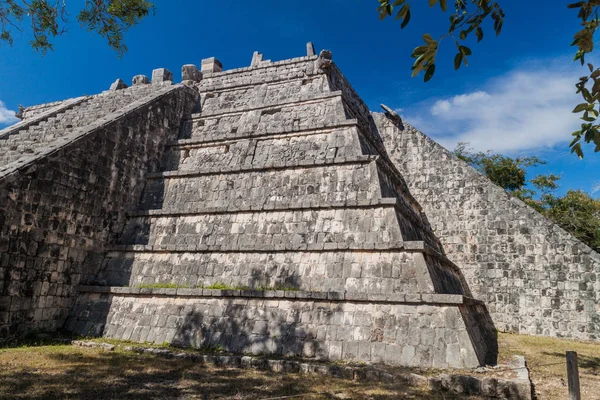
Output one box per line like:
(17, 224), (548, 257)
(0, 345), (474, 400)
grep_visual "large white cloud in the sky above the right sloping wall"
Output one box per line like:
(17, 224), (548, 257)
(405, 65), (581, 153)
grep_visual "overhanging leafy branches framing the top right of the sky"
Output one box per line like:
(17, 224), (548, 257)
(377, 0), (600, 158)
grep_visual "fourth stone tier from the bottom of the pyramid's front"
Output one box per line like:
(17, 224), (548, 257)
(140, 164), (379, 213)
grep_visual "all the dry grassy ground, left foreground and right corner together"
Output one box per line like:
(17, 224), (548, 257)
(0, 334), (600, 400)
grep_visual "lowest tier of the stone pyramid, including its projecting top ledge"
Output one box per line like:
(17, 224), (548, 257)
(67, 287), (497, 368)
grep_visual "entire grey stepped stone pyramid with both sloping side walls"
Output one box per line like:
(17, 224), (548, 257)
(0, 43), (600, 368)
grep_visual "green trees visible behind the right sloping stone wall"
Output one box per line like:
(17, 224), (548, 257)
(453, 143), (600, 251)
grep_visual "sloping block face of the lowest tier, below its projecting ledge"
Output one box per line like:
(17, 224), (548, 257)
(67, 293), (486, 368)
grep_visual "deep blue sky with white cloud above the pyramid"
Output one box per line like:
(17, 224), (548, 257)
(0, 0), (600, 195)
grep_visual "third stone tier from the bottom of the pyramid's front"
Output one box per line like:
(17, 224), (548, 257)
(121, 204), (410, 250)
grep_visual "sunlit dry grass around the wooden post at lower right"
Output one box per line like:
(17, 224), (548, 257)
(499, 334), (600, 400)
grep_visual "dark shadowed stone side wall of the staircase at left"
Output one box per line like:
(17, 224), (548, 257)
(0, 85), (197, 335)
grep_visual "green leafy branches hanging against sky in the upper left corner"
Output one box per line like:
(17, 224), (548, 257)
(0, 0), (154, 56)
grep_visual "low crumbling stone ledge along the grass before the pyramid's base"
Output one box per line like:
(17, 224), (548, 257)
(72, 341), (532, 400)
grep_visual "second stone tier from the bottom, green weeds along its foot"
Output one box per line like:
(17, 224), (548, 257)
(94, 242), (469, 294)
